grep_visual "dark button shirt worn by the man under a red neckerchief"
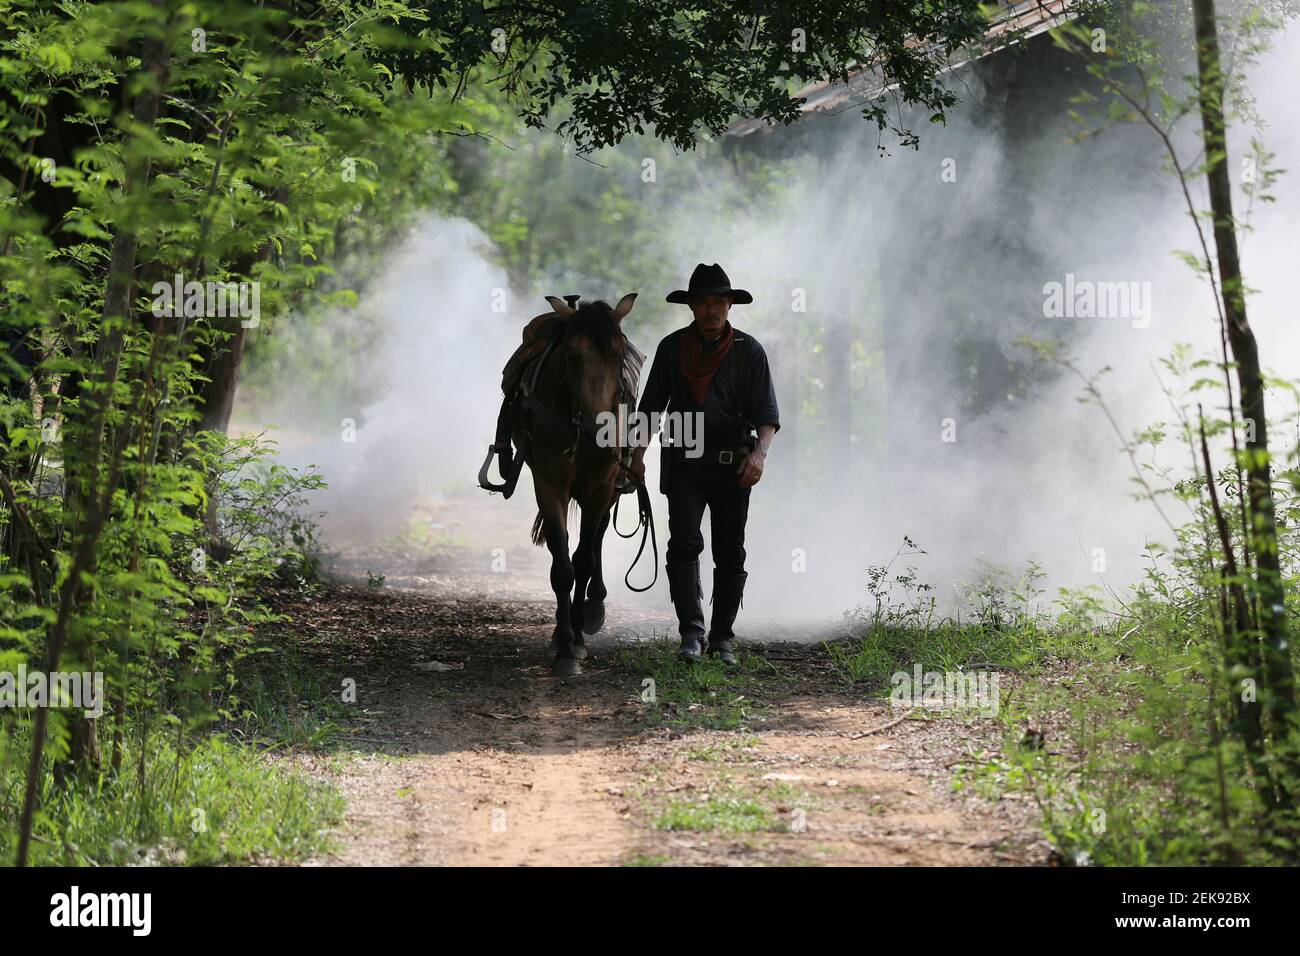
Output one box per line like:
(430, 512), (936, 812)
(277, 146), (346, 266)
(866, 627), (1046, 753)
(637, 325), (781, 451)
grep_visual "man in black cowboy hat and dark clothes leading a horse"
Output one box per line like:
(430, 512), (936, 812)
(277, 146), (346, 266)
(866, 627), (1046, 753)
(631, 263), (781, 665)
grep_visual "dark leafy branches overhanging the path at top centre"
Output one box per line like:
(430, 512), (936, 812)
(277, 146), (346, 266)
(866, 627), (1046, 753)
(449, 0), (987, 151)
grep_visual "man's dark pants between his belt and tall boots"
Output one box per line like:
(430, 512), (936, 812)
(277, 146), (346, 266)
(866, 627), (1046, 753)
(666, 459), (753, 575)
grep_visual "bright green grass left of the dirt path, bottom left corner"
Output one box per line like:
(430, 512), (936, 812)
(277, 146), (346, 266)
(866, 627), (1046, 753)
(0, 629), (356, 866)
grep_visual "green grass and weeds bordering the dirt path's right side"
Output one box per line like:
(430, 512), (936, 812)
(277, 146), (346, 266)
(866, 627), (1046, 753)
(800, 542), (1300, 865)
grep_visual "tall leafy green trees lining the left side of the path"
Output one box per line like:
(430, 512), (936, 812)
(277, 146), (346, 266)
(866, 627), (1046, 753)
(0, 1), (467, 858)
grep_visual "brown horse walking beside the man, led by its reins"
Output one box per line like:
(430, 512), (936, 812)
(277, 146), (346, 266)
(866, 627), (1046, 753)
(514, 293), (640, 676)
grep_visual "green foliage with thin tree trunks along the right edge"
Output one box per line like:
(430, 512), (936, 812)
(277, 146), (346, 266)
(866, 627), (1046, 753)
(1022, 3), (1300, 862)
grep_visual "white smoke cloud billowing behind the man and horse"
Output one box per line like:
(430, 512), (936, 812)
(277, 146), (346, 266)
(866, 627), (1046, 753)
(237, 22), (1300, 629)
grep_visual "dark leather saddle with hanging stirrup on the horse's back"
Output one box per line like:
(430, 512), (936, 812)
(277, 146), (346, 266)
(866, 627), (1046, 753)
(478, 303), (645, 498)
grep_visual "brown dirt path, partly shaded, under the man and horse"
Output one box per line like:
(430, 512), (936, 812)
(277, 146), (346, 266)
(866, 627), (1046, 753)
(285, 564), (1048, 865)
